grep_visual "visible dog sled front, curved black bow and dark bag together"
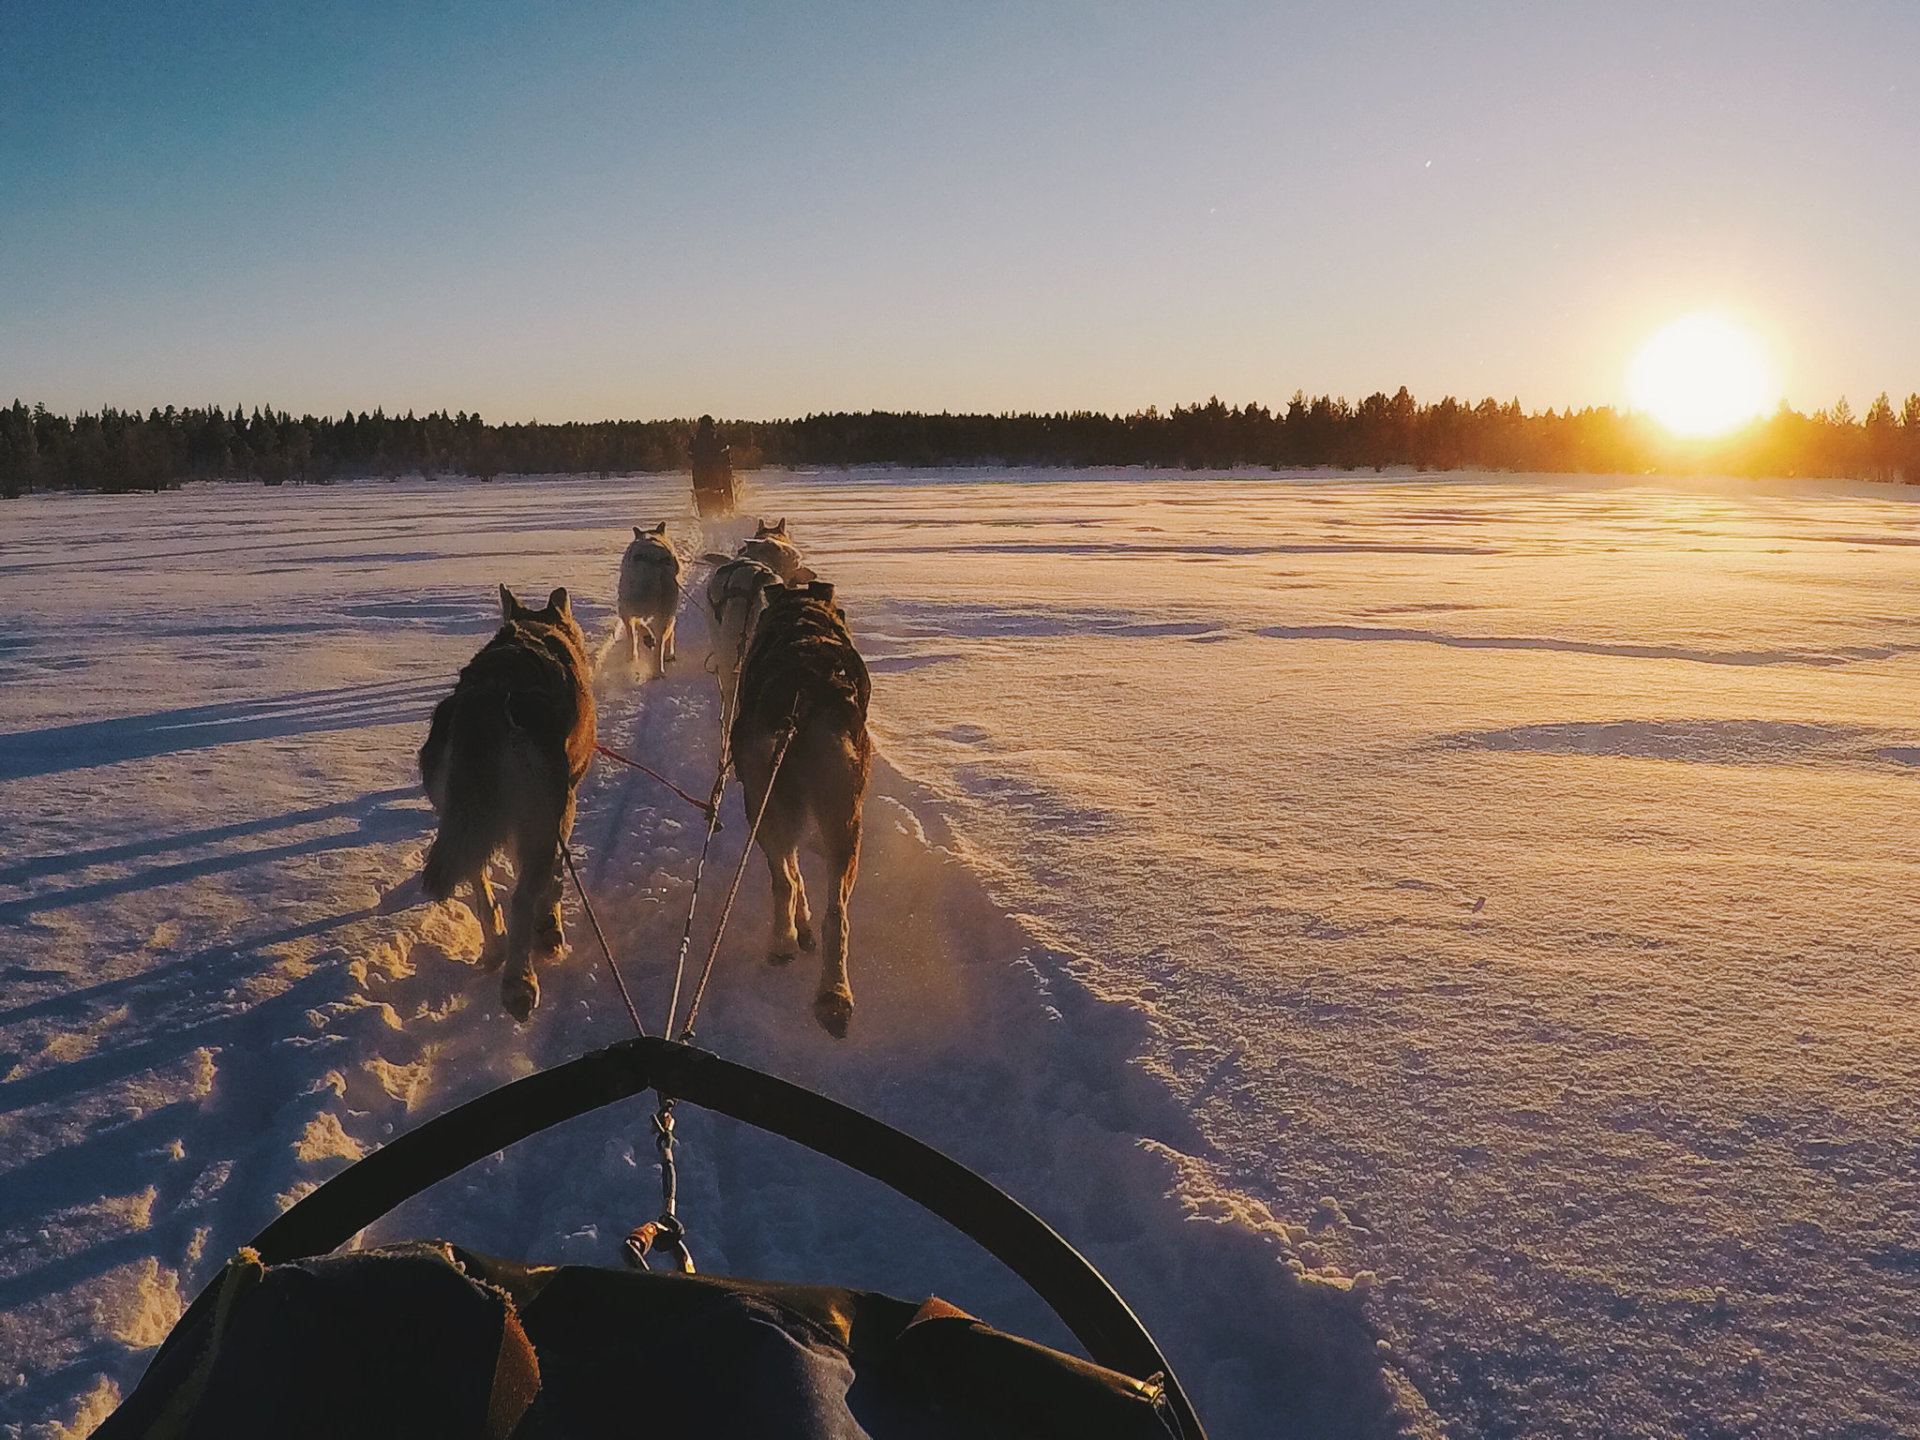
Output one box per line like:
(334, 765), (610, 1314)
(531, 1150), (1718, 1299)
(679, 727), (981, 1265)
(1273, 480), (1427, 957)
(96, 1039), (1204, 1440)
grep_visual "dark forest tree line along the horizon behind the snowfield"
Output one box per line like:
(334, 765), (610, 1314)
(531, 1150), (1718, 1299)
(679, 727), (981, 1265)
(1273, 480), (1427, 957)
(0, 386), (1920, 497)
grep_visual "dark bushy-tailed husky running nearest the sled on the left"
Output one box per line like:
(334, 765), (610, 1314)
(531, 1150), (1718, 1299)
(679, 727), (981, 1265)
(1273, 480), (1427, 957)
(420, 586), (593, 1020)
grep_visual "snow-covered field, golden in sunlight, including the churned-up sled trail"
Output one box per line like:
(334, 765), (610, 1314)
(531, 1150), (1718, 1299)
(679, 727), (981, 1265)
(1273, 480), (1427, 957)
(0, 470), (1920, 1438)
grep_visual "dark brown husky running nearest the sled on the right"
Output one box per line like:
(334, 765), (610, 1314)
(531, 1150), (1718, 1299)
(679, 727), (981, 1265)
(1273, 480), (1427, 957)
(733, 582), (874, 1039)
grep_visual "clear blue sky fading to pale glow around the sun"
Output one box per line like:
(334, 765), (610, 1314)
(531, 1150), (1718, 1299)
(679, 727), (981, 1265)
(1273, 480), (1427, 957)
(0, 0), (1920, 420)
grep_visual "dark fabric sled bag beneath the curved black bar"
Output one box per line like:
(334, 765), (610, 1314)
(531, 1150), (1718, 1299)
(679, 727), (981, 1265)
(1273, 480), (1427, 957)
(105, 1242), (1177, 1440)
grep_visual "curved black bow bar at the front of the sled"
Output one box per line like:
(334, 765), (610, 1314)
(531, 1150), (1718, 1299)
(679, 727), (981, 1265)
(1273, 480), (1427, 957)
(240, 1037), (1206, 1440)
